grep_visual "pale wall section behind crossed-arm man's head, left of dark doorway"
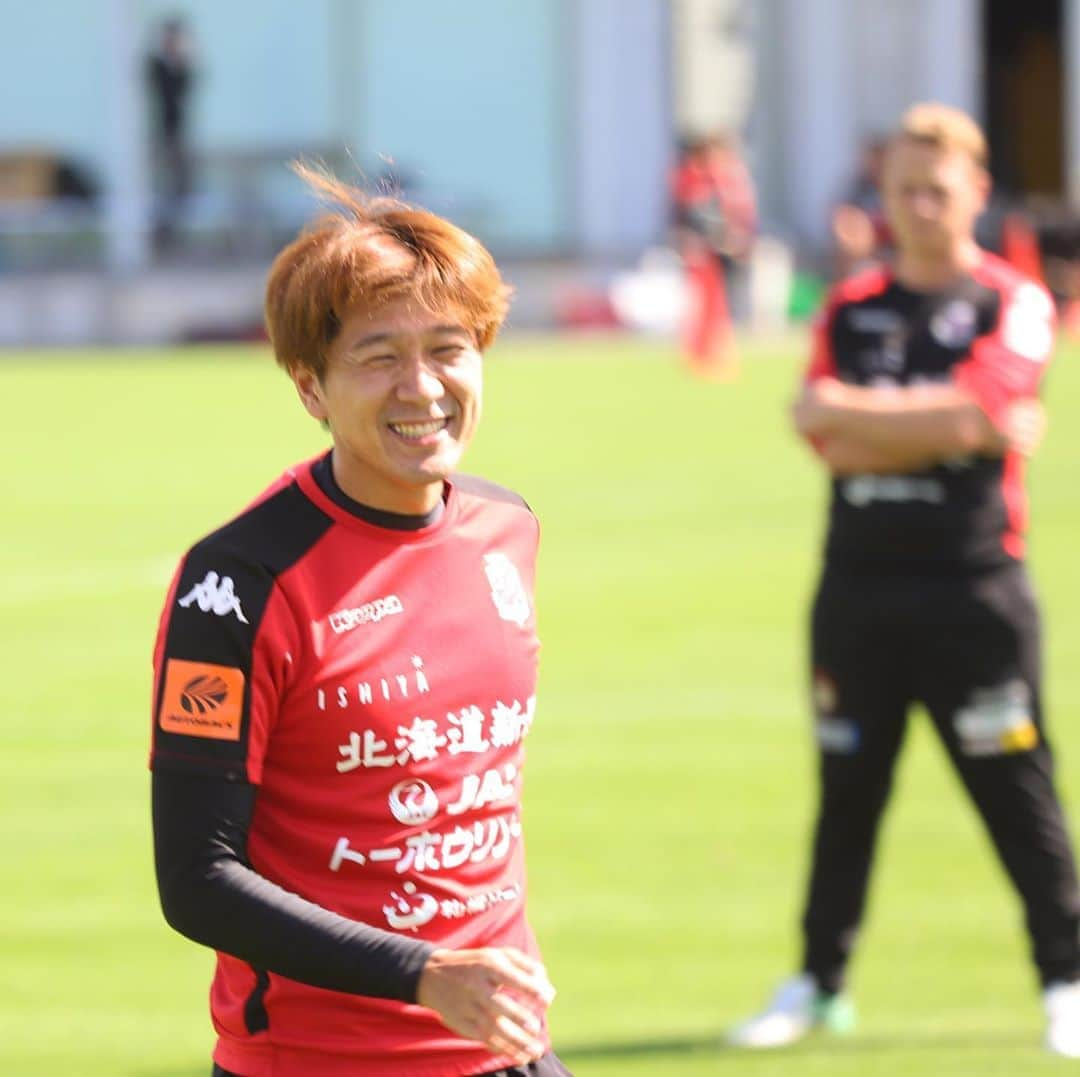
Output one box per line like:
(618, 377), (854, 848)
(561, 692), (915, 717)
(753, 0), (984, 247)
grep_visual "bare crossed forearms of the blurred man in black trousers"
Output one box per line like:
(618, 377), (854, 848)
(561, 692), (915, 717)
(792, 377), (1045, 475)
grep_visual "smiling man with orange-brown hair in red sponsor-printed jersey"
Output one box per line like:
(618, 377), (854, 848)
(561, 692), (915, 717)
(151, 169), (567, 1077)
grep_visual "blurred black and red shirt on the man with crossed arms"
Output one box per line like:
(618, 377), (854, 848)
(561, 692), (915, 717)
(808, 252), (1054, 573)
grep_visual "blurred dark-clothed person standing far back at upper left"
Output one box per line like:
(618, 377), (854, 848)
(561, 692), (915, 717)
(146, 18), (194, 245)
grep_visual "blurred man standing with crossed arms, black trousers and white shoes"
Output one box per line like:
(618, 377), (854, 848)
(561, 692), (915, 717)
(731, 105), (1080, 1056)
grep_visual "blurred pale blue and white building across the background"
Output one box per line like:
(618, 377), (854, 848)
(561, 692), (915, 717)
(0, 0), (1080, 344)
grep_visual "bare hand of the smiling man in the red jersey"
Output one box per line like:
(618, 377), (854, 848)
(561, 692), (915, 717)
(416, 946), (555, 1065)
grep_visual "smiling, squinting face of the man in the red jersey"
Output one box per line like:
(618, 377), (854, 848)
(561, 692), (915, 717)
(293, 298), (483, 514)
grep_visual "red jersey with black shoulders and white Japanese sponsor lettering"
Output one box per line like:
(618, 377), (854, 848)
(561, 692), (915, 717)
(151, 462), (539, 1077)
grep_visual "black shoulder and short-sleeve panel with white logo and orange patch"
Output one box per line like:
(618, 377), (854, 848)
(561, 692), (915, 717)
(153, 484), (333, 780)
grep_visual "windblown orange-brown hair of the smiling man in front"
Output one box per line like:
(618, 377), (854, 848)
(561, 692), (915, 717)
(264, 163), (511, 379)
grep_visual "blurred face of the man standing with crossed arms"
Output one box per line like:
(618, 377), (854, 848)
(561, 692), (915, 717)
(881, 138), (989, 257)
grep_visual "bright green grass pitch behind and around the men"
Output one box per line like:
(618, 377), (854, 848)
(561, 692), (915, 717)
(0, 338), (1080, 1077)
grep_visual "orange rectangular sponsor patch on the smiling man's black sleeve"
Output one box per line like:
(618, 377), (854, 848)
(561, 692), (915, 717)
(158, 658), (244, 740)
